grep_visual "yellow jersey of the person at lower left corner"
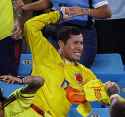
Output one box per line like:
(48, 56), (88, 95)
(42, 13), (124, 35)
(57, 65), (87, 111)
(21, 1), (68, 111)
(5, 89), (41, 117)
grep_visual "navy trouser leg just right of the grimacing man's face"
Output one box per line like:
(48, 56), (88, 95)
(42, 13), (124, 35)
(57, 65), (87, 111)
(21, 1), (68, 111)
(80, 27), (97, 67)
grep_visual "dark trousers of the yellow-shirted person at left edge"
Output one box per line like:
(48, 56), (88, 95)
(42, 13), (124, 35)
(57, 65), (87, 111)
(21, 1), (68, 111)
(0, 37), (17, 75)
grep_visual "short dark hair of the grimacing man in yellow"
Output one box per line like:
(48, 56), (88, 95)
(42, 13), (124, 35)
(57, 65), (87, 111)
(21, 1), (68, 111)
(57, 26), (82, 43)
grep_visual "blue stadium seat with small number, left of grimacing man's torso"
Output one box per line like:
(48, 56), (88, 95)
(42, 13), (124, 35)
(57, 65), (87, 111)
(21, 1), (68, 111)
(18, 53), (32, 76)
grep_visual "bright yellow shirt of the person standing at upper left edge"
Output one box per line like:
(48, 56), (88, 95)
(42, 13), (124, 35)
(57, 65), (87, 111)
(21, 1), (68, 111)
(0, 0), (13, 40)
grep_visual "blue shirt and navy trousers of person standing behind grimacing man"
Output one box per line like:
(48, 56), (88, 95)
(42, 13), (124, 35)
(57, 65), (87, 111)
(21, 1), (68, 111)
(52, 0), (104, 67)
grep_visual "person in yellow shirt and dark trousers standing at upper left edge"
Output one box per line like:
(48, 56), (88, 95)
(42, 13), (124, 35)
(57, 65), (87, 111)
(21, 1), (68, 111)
(0, 0), (21, 75)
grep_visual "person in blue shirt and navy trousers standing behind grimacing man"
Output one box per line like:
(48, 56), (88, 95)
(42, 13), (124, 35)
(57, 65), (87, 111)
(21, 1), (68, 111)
(52, 0), (111, 67)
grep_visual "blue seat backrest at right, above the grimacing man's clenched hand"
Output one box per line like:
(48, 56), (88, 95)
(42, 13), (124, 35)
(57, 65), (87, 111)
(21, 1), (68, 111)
(92, 53), (124, 74)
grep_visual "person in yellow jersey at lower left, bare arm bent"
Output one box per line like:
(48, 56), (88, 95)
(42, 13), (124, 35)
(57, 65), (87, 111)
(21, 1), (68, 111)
(0, 75), (44, 117)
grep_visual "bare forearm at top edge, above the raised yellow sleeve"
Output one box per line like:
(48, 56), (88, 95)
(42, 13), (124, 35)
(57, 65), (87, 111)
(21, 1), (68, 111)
(22, 0), (49, 11)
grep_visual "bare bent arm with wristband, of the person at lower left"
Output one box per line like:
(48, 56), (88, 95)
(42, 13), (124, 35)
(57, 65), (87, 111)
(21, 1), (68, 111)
(0, 75), (44, 93)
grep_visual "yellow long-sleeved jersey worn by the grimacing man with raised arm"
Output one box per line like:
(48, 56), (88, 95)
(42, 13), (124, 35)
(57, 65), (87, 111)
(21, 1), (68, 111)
(24, 11), (109, 117)
